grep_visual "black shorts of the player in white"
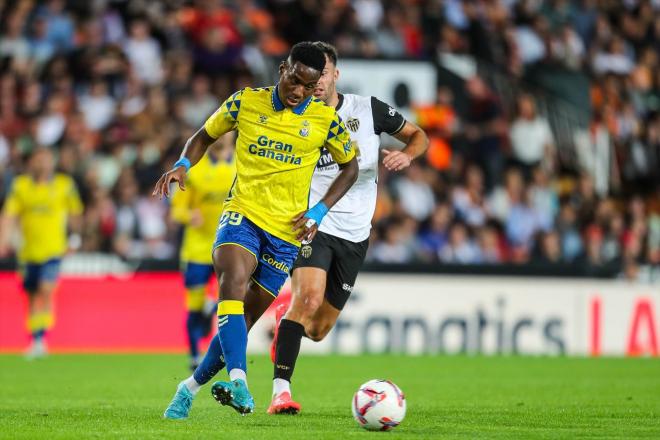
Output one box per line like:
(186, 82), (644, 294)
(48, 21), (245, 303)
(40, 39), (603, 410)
(292, 231), (369, 310)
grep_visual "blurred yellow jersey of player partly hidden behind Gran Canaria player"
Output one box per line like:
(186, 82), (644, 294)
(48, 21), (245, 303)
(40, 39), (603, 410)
(171, 154), (236, 264)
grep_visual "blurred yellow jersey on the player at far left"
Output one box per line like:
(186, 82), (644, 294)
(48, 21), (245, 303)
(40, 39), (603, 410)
(4, 174), (83, 263)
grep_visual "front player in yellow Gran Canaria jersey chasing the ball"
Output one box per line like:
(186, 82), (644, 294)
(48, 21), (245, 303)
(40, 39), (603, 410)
(159, 42), (358, 419)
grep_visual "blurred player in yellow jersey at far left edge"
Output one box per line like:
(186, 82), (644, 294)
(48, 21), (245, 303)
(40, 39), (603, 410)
(0, 148), (82, 357)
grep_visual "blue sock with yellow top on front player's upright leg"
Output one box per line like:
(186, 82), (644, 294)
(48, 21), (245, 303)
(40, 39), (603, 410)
(218, 300), (247, 380)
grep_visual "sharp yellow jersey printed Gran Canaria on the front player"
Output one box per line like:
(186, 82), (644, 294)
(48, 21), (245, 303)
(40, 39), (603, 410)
(204, 86), (355, 246)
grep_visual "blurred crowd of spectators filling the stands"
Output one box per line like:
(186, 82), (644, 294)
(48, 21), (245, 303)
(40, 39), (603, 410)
(0, 0), (660, 277)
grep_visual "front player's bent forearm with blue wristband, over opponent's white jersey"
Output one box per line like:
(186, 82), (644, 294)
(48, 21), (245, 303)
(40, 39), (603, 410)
(293, 156), (359, 241)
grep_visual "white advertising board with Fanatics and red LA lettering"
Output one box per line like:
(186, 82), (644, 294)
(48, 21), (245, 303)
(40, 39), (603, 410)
(253, 274), (660, 356)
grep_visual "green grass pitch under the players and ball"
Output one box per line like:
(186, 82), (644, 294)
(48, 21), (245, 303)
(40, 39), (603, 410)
(0, 355), (660, 440)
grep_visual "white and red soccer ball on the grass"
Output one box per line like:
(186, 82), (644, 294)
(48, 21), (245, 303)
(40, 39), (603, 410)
(351, 379), (406, 431)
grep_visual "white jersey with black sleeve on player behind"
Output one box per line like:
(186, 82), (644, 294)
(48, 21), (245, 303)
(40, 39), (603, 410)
(309, 94), (406, 243)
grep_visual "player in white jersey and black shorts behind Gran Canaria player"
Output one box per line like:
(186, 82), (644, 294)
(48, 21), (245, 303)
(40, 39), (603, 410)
(268, 42), (428, 414)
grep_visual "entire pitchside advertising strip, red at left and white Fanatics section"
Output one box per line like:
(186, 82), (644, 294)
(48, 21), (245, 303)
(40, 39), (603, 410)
(0, 273), (660, 356)
